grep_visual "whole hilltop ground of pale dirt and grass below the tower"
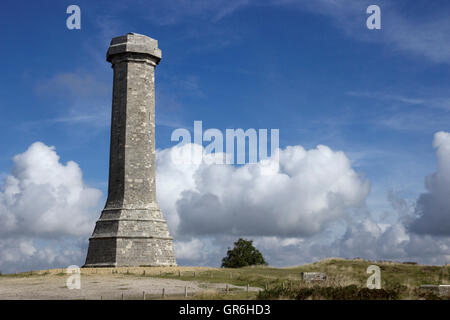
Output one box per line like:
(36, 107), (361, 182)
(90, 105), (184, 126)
(0, 258), (450, 299)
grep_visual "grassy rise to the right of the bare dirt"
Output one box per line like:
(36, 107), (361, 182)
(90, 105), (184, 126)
(152, 258), (450, 299)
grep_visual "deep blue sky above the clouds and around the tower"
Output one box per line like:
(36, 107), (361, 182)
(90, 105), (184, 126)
(0, 0), (450, 272)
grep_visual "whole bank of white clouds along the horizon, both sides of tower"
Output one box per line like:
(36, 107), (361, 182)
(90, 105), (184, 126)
(0, 132), (450, 272)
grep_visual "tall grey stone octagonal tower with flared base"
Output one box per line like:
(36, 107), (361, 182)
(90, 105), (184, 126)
(84, 33), (176, 267)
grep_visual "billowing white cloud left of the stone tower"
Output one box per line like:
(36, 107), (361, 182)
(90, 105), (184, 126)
(0, 142), (102, 271)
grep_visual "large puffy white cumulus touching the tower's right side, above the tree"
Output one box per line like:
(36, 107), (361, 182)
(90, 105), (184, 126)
(157, 144), (370, 237)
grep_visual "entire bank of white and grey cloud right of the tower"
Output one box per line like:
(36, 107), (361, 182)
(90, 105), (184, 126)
(157, 139), (450, 266)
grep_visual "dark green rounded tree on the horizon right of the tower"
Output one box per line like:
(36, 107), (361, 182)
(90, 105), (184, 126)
(222, 238), (267, 268)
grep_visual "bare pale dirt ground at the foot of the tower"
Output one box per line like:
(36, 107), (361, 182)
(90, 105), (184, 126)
(0, 270), (259, 300)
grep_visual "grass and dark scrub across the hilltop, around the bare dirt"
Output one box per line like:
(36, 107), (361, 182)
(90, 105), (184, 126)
(5, 258), (444, 300)
